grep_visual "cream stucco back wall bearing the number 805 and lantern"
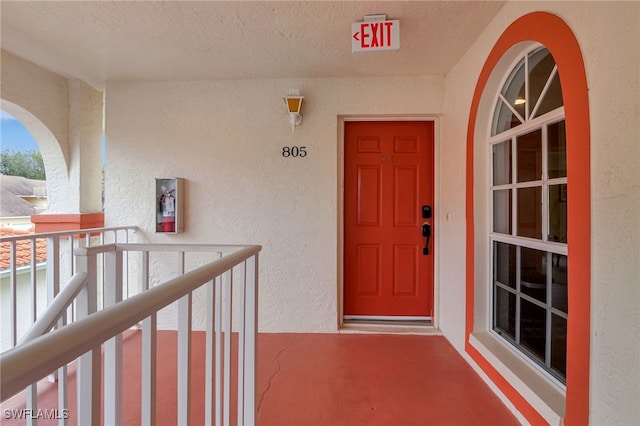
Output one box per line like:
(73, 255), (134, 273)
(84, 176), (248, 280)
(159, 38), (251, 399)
(105, 77), (443, 332)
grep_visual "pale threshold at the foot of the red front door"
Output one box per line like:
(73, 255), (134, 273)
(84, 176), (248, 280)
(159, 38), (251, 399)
(339, 316), (442, 335)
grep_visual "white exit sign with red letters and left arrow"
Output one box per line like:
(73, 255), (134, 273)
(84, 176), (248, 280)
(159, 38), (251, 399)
(351, 15), (400, 53)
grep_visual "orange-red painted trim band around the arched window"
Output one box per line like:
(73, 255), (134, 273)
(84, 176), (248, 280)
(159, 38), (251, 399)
(465, 12), (591, 425)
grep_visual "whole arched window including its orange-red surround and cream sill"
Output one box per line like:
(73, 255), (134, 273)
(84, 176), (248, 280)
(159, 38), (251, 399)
(465, 12), (591, 425)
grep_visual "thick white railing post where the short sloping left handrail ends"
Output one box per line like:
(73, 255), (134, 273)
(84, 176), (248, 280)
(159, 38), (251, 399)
(76, 249), (102, 425)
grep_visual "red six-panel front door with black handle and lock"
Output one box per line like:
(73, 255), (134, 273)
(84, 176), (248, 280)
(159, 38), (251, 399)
(344, 121), (434, 317)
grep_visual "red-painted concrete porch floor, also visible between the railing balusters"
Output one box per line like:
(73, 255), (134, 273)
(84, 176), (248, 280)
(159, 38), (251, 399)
(0, 331), (518, 426)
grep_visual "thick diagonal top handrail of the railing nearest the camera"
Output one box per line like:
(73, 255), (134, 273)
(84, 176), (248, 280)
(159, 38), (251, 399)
(0, 245), (262, 400)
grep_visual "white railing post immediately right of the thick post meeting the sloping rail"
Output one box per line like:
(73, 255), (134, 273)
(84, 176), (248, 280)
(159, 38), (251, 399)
(104, 250), (122, 426)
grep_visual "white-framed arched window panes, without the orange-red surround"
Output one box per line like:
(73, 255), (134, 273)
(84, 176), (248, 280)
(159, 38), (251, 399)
(488, 45), (568, 384)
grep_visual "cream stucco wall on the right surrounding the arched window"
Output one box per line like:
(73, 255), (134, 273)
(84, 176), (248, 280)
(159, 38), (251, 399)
(440, 2), (640, 425)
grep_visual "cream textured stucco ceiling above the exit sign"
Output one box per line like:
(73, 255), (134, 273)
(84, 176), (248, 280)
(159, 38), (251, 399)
(0, 1), (504, 87)
